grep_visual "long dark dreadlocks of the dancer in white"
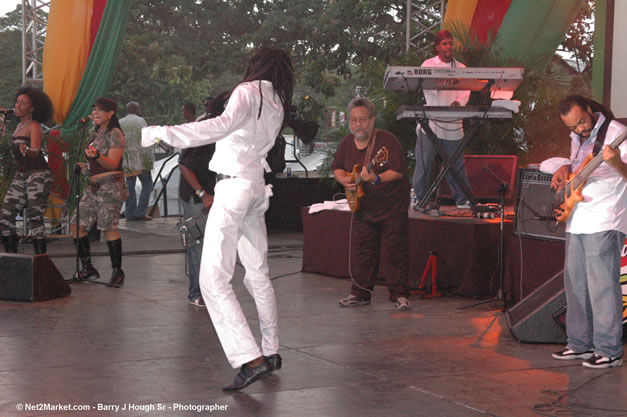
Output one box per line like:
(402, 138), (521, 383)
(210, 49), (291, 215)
(242, 47), (294, 121)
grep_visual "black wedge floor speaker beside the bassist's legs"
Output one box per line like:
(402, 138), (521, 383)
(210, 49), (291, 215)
(505, 271), (566, 343)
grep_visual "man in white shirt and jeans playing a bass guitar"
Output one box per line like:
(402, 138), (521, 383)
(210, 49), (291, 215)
(551, 95), (627, 368)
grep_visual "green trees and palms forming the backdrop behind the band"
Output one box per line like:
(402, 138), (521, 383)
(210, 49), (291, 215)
(0, 0), (594, 167)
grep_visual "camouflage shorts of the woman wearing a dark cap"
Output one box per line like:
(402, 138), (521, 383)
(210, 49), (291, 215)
(71, 179), (128, 230)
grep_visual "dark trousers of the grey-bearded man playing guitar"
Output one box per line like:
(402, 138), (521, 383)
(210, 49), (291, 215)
(350, 213), (409, 301)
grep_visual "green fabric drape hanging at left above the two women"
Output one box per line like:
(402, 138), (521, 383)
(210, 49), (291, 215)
(61, 0), (131, 134)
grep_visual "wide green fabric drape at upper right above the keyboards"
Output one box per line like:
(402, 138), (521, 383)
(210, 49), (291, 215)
(493, 0), (583, 70)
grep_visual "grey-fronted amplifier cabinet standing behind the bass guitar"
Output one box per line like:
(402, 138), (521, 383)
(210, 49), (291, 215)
(514, 169), (566, 240)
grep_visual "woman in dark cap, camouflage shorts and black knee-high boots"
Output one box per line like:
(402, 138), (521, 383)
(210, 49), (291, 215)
(71, 97), (128, 287)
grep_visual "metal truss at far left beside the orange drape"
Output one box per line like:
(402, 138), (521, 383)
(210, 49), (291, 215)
(22, 0), (50, 87)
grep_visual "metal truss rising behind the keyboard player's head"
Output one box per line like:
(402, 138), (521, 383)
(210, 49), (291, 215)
(405, 0), (446, 51)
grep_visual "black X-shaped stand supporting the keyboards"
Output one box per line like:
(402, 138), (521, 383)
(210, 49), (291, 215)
(414, 117), (485, 211)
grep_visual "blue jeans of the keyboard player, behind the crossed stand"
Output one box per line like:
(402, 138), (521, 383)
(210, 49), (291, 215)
(411, 130), (470, 204)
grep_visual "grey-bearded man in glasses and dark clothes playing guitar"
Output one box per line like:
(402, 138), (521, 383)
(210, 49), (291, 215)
(331, 97), (410, 310)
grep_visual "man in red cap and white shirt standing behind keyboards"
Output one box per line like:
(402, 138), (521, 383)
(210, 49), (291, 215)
(412, 30), (470, 209)
